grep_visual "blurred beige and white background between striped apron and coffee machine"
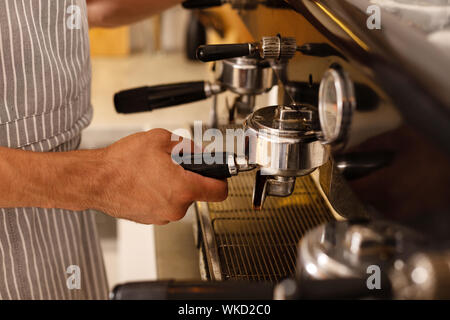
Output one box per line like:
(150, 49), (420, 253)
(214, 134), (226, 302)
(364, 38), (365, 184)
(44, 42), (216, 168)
(81, 6), (250, 288)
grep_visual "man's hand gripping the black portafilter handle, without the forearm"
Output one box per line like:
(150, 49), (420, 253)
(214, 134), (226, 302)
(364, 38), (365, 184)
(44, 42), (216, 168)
(93, 129), (228, 225)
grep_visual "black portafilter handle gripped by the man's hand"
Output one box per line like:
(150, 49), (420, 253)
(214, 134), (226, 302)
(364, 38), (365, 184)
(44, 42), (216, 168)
(172, 152), (234, 180)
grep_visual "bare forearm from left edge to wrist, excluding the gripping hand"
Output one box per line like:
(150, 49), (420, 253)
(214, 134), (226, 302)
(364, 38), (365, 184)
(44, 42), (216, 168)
(0, 147), (101, 210)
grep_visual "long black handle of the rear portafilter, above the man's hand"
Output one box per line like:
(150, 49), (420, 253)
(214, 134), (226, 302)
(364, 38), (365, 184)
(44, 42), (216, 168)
(114, 81), (207, 113)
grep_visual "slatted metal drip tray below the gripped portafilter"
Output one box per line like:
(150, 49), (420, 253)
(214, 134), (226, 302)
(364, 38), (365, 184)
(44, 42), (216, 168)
(198, 173), (335, 282)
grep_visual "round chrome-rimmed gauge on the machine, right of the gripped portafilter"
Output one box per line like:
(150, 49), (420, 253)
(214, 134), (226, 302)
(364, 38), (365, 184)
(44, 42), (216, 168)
(319, 68), (356, 144)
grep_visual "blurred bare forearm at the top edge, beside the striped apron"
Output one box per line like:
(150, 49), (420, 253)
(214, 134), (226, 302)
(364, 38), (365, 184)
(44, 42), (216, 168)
(87, 0), (182, 27)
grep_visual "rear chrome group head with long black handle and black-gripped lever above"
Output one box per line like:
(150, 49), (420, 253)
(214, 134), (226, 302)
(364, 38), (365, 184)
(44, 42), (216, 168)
(114, 36), (297, 122)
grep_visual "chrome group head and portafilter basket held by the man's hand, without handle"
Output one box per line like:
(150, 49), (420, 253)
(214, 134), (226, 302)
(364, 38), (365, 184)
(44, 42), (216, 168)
(244, 105), (329, 177)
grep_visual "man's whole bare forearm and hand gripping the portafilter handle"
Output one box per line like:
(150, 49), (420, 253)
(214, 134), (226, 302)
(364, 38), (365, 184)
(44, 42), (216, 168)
(0, 129), (227, 224)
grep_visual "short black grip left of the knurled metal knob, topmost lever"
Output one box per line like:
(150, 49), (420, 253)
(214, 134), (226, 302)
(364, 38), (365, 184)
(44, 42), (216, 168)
(197, 43), (251, 62)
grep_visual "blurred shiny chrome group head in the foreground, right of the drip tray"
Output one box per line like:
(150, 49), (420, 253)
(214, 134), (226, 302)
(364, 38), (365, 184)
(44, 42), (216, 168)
(297, 220), (425, 279)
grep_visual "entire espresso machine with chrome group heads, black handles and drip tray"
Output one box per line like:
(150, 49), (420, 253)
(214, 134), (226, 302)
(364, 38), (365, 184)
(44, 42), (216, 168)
(110, 0), (450, 299)
